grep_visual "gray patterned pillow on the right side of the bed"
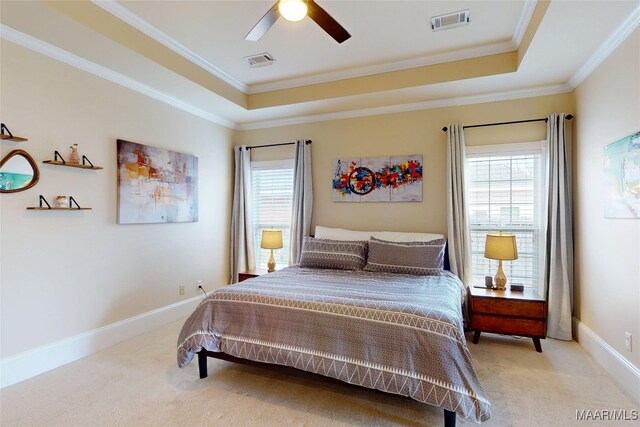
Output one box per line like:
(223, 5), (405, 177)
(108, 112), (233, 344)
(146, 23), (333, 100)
(364, 237), (446, 276)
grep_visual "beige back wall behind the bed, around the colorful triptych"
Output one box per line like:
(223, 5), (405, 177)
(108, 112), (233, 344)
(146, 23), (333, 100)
(234, 94), (573, 234)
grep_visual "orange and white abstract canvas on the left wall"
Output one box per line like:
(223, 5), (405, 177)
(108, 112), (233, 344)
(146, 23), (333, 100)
(118, 139), (198, 224)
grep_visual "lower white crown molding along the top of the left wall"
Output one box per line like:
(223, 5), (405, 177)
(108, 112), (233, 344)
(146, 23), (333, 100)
(0, 24), (237, 129)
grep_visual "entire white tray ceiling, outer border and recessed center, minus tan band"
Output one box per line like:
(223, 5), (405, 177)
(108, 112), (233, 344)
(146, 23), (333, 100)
(0, 0), (640, 129)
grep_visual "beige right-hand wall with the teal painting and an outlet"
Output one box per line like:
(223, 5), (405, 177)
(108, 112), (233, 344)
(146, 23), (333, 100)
(573, 30), (640, 367)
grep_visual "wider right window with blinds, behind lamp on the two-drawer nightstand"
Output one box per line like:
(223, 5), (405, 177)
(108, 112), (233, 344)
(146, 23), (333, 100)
(466, 141), (546, 289)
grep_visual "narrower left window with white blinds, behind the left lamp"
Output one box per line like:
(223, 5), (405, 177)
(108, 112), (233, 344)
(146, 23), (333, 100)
(251, 160), (293, 270)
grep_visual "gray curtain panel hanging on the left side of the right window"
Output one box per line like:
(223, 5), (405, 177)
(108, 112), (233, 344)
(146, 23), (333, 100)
(447, 124), (471, 285)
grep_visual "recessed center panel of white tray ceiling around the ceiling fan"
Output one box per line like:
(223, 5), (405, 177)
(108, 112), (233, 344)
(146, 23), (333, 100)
(120, 0), (525, 85)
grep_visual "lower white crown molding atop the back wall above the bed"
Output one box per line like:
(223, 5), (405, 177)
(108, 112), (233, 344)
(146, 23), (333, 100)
(236, 84), (573, 131)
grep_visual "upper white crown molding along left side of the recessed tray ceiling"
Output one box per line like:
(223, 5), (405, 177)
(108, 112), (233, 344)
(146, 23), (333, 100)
(91, 0), (249, 94)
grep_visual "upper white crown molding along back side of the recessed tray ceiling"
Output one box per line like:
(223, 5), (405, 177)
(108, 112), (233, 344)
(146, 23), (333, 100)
(247, 40), (516, 95)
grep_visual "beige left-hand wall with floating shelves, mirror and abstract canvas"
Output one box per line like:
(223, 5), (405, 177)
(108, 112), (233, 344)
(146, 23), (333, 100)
(0, 41), (232, 357)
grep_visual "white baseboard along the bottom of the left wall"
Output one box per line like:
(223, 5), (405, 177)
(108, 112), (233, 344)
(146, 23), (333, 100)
(0, 296), (202, 388)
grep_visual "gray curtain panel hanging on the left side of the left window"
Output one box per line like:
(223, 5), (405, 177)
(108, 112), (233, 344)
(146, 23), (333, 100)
(231, 145), (256, 283)
